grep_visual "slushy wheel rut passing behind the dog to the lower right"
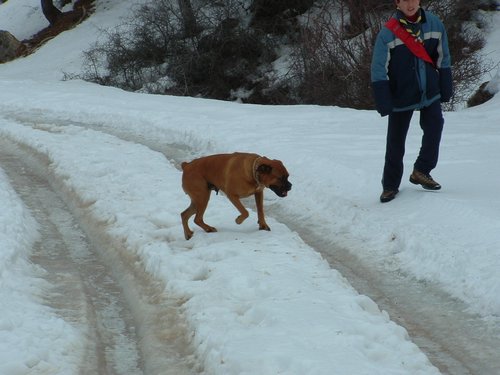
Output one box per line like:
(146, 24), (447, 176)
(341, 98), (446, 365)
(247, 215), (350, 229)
(46, 118), (500, 375)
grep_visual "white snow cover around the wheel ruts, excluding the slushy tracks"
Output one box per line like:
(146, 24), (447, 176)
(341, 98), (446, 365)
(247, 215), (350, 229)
(0, 0), (500, 375)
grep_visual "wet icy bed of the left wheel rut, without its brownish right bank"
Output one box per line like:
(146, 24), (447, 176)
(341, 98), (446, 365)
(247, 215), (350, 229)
(0, 147), (142, 375)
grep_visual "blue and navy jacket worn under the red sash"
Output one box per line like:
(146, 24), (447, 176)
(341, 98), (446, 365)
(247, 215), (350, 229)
(371, 9), (452, 116)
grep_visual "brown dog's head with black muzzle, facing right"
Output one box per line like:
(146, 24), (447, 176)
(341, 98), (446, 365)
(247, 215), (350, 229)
(256, 157), (292, 198)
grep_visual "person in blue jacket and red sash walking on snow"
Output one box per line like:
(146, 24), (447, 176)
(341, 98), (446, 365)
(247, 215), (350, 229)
(371, 0), (452, 203)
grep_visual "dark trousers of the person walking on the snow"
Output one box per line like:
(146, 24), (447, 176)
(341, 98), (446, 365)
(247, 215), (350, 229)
(382, 100), (444, 190)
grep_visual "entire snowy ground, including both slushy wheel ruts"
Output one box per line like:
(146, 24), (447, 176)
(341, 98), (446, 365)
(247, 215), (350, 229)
(0, 0), (500, 375)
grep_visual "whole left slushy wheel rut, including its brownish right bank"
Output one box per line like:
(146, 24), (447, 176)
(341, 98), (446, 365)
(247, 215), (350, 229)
(0, 142), (196, 375)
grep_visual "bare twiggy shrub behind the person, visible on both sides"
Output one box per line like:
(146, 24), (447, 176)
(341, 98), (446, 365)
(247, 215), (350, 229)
(292, 0), (490, 109)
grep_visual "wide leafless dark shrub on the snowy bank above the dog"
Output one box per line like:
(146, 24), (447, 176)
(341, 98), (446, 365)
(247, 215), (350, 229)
(78, 0), (275, 99)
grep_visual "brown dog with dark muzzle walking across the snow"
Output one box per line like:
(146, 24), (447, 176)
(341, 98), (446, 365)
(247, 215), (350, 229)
(181, 152), (292, 240)
